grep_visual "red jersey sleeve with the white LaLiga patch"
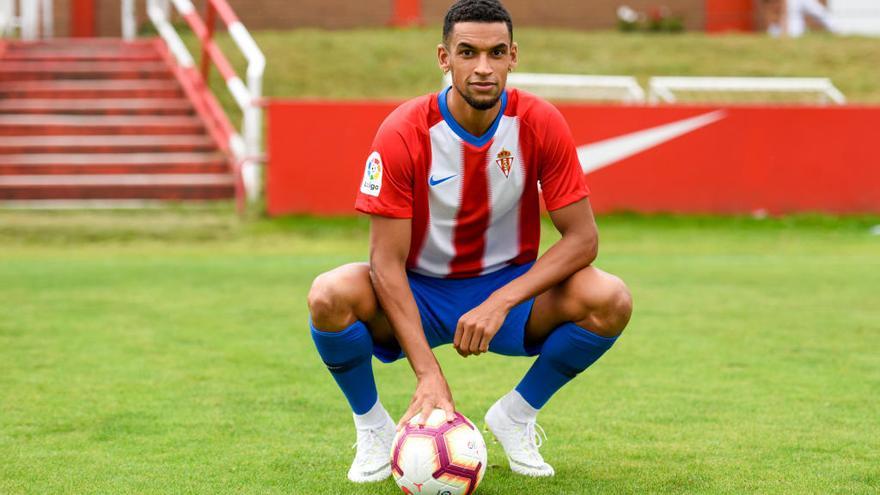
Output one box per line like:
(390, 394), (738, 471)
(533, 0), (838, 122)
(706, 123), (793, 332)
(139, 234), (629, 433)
(355, 124), (413, 218)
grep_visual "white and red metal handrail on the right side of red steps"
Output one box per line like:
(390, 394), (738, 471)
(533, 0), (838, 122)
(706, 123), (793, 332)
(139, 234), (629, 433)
(147, 0), (266, 202)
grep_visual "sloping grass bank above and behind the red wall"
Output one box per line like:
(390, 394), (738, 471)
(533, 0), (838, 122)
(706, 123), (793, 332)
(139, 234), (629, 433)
(194, 26), (880, 114)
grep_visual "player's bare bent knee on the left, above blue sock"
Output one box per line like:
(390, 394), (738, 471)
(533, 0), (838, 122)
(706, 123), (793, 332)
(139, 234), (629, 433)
(308, 266), (363, 332)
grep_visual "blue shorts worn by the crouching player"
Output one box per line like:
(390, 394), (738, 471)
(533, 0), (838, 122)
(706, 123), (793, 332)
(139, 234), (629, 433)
(373, 262), (541, 363)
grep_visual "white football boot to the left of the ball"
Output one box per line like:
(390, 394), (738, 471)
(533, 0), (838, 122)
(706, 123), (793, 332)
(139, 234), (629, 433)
(348, 406), (397, 483)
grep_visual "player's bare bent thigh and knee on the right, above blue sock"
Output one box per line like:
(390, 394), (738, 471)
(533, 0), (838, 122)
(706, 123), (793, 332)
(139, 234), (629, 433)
(525, 266), (626, 346)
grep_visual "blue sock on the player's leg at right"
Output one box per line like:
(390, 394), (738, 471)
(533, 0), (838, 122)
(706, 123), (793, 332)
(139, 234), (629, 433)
(516, 322), (617, 409)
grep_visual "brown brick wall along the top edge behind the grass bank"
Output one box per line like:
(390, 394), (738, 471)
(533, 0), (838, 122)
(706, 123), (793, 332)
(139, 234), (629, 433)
(55, 0), (705, 36)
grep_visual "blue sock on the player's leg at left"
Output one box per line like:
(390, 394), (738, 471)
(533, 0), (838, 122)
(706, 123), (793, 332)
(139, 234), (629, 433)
(309, 321), (379, 414)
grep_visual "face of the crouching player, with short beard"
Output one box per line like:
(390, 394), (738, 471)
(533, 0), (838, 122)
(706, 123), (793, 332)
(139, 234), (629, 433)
(437, 22), (516, 110)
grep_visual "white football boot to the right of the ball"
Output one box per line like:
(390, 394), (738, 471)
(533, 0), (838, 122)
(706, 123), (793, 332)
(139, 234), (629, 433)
(485, 400), (555, 476)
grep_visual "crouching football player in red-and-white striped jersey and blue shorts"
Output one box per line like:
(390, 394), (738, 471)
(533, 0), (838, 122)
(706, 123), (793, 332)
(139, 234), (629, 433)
(308, 0), (632, 482)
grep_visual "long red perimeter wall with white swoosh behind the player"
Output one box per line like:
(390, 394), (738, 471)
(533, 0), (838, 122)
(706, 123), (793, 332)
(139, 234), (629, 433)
(267, 100), (880, 215)
